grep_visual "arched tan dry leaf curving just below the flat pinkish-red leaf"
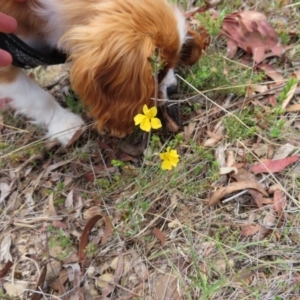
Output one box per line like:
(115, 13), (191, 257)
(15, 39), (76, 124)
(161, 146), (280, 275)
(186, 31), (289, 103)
(208, 181), (268, 206)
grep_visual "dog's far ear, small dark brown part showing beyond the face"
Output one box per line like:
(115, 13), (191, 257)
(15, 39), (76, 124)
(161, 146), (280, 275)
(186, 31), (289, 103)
(179, 29), (209, 66)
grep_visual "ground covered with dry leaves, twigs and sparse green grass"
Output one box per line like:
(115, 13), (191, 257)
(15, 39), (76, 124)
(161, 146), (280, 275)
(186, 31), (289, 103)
(0, 0), (300, 300)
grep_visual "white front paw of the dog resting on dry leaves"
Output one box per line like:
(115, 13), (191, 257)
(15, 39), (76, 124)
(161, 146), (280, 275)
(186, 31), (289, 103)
(47, 108), (84, 146)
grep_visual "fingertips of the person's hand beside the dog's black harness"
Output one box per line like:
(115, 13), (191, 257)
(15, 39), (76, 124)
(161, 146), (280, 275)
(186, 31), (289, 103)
(0, 0), (26, 67)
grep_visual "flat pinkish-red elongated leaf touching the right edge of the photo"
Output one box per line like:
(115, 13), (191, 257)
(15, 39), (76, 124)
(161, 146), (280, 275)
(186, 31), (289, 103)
(250, 155), (299, 174)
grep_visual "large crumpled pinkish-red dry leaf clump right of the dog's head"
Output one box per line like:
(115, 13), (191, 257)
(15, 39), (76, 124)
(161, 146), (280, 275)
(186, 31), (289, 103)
(222, 10), (284, 63)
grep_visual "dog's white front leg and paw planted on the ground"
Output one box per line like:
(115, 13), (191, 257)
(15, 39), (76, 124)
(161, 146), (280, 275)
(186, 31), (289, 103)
(0, 71), (84, 146)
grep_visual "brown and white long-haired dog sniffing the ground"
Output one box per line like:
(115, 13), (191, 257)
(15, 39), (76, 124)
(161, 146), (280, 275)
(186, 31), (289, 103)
(0, 0), (203, 145)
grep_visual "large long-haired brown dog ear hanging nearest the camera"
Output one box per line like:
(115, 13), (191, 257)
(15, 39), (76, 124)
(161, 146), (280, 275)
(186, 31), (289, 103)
(66, 28), (155, 137)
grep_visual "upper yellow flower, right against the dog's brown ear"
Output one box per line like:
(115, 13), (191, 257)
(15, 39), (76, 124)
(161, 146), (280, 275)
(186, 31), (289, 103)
(134, 104), (161, 132)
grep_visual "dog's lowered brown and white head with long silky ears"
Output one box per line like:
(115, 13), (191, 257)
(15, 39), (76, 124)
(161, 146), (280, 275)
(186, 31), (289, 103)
(62, 0), (203, 137)
